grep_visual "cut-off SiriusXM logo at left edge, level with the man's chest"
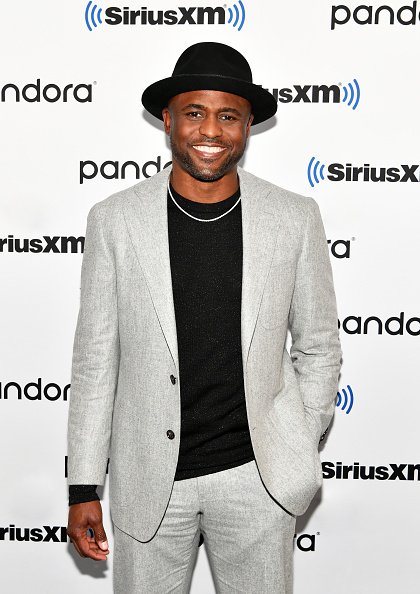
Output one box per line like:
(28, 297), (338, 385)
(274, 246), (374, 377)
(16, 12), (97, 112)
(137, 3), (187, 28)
(0, 235), (85, 254)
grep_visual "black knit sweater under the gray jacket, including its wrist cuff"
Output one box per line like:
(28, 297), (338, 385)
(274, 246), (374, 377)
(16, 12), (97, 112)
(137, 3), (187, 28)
(69, 180), (254, 505)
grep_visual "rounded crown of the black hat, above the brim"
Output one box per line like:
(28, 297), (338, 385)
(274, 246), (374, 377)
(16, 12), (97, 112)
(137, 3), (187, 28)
(172, 41), (252, 83)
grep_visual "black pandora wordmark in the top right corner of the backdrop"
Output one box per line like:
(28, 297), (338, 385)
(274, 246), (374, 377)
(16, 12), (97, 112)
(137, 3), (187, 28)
(331, 0), (420, 29)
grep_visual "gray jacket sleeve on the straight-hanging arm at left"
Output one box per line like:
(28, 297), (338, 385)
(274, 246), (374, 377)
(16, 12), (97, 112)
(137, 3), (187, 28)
(68, 204), (119, 485)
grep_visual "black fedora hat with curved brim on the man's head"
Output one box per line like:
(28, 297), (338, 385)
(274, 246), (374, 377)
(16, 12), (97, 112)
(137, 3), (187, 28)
(141, 41), (277, 124)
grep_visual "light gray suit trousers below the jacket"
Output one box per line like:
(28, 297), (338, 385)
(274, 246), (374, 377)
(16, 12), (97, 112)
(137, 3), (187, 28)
(114, 461), (295, 594)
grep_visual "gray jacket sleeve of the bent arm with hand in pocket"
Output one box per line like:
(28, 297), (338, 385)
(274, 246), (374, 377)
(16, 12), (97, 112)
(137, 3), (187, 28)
(289, 199), (341, 443)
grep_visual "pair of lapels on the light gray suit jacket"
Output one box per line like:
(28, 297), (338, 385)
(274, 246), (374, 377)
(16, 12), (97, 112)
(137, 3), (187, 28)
(120, 164), (278, 370)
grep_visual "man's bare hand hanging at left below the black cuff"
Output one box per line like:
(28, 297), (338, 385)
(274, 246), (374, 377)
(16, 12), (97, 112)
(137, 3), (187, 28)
(67, 501), (109, 561)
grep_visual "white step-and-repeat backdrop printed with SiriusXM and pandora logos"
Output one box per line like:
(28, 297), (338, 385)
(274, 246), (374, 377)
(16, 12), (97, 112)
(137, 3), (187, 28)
(0, 0), (420, 594)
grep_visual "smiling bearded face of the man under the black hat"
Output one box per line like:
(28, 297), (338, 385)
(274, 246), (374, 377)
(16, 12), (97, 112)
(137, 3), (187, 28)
(162, 91), (253, 182)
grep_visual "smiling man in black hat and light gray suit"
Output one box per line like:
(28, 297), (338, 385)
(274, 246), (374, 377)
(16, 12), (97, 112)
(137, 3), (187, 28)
(68, 43), (341, 594)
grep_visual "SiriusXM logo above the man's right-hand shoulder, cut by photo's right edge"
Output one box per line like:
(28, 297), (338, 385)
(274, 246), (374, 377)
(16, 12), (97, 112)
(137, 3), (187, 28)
(306, 157), (420, 188)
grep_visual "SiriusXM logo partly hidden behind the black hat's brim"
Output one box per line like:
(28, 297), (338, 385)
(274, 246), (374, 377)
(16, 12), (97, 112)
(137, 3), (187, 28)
(266, 78), (360, 110)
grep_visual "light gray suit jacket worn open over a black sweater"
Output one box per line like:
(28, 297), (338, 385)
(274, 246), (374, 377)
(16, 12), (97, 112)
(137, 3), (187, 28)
(68, 169), (341, 541)
